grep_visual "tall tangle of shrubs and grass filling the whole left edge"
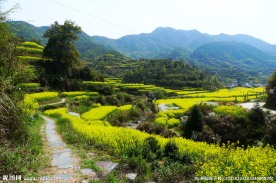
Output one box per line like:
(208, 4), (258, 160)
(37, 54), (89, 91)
(0, 0), (46, 176)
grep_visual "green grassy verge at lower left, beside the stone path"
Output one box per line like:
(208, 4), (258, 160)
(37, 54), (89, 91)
(0, 116), (50, 177)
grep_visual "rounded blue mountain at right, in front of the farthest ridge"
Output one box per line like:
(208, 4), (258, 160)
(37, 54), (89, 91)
(190, 42), (276, 80)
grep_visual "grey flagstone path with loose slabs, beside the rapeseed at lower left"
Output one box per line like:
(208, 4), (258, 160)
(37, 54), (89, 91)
(41, 113), (137, 183)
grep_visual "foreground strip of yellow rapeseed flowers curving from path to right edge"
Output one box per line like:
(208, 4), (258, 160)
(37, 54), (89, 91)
(45, 106), (276, 177)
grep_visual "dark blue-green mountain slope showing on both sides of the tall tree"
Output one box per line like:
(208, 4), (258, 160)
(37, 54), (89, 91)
(8, 21), (120, 59)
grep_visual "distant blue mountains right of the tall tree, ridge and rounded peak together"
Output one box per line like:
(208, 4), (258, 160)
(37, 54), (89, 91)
(92, 27), (276, 83)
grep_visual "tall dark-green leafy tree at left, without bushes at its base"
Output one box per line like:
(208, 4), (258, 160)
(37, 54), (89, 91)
(43, 20), (81, 76)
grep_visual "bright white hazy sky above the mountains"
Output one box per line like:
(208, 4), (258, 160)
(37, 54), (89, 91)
(2, 0), (276, 44)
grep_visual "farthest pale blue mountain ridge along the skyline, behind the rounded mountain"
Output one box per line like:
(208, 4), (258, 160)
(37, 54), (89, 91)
(92, 27), (276, 59)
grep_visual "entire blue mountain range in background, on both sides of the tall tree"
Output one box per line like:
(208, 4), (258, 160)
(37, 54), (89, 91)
(9, 21), (276, 85)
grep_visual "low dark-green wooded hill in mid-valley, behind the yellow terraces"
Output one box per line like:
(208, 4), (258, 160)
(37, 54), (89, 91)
(123, 60), (220, 90)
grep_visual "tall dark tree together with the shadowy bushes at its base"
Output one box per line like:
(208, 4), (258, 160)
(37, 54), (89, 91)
(37, 21), (103, 90)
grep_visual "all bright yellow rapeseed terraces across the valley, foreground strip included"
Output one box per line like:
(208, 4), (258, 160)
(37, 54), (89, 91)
(20, 86), (276, 180)
